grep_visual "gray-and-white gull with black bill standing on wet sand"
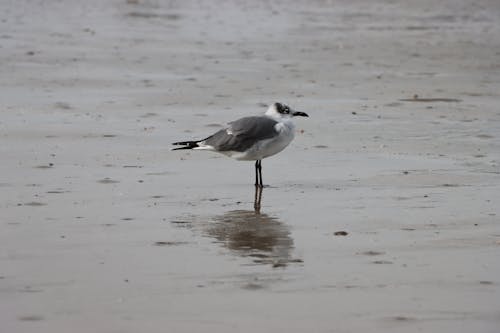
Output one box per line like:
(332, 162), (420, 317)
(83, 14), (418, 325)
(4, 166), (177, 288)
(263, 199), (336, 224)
(173, 103), (309, 187)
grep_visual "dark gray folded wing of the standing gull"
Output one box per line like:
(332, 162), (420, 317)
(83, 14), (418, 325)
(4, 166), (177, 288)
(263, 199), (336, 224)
(203, 117), (278, 152)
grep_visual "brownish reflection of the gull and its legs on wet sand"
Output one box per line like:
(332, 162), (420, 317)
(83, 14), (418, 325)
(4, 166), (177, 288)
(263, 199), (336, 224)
(205, 186), (302, 267)
